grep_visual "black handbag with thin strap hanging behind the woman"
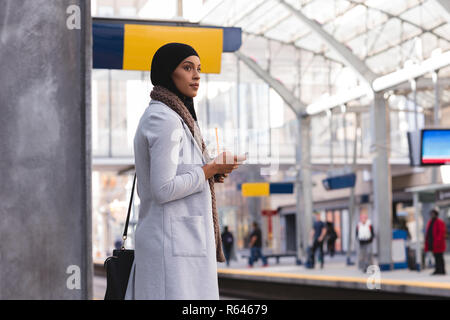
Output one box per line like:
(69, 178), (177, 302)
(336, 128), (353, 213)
(103, 174), (136, 300)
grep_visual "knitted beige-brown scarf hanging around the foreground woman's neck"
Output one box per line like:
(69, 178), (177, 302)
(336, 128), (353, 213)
(150, 86), (225, 262)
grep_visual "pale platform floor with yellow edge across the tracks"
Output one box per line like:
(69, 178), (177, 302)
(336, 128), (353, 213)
(218, 252), (450, 297)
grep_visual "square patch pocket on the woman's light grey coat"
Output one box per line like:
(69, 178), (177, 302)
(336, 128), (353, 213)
(170, 216), (206, 257)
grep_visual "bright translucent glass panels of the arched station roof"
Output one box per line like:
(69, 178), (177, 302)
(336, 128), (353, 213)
(200, 0), (450, 107)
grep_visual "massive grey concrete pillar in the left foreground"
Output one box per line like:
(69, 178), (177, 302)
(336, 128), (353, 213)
(0, 0), (93, 300)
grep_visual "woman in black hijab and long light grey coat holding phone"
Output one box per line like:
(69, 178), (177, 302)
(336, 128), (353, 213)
(125, 43), (245, 299)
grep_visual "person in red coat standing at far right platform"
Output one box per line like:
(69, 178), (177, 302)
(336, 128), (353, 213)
(425, 209), (446, 275)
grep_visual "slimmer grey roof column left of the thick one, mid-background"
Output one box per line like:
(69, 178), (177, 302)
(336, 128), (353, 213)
(295, 115), (313, 264)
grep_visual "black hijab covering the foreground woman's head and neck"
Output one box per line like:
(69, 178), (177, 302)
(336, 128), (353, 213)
(150, 42), (199, 121)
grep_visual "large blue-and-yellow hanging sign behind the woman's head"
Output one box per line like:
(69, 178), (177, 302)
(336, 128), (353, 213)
(92, 18), (242, 73)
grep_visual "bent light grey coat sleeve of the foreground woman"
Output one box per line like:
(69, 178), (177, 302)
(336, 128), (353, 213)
(144, 112), (206, 204)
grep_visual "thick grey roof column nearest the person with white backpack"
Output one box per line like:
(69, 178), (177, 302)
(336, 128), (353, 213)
(371, 93), (392, 270)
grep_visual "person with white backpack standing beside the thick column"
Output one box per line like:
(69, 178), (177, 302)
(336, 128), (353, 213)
(356, 213), (374, 273)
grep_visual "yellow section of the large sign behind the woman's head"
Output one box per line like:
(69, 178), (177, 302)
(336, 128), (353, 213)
(123, 24), (223, 73)
